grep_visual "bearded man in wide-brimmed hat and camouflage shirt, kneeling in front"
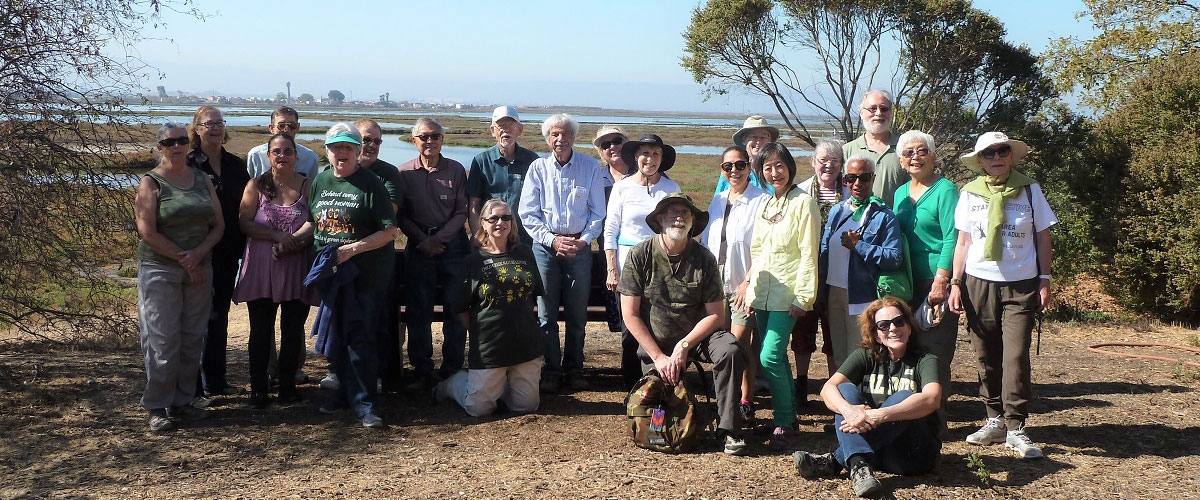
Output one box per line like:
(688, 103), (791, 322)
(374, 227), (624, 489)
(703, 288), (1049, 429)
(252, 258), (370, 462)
(617, 193), (749, 454)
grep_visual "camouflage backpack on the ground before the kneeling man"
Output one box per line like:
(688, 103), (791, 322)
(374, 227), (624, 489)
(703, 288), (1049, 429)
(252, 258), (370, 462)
(625, 372), (704, 453)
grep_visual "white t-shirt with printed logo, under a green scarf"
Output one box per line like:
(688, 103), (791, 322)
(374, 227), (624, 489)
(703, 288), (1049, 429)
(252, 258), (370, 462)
(954, 185), (1058, 282)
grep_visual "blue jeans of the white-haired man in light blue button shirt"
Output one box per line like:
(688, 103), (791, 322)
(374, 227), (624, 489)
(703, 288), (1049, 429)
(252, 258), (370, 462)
(533, 243), (592, 373)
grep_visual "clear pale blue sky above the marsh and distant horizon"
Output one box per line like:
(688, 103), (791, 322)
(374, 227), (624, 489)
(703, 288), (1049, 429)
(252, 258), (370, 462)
(137, 0), (1091, 114)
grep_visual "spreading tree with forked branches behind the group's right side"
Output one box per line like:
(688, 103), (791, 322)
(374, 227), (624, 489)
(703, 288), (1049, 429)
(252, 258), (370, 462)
(683, 0), (1052, 157)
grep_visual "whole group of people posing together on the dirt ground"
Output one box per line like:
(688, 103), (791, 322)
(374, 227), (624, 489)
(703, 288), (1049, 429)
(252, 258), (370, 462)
(136, 91), (1057, 495)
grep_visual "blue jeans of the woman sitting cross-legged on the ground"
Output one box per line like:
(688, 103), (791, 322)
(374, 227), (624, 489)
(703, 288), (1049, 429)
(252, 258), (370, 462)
(833, 382), (942, 475)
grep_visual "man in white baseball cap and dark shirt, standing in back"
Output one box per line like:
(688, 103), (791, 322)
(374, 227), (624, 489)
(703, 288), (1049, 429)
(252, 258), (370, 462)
(467, 106), (538, 245)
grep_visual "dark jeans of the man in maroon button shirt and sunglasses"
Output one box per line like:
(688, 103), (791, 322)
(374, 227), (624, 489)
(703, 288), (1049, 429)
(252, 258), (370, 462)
(404, 233), (469, 376)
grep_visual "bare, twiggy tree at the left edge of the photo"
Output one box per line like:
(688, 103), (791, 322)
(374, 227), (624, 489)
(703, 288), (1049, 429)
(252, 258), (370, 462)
(0, 0), (201, 339)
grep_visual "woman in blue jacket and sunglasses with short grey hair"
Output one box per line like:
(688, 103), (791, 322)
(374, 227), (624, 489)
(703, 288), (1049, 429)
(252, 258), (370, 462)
(821, 155), (904, 366)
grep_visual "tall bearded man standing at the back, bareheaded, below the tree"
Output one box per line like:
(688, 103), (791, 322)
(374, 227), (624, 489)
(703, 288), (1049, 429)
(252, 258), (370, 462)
(841, 90), (908, 209)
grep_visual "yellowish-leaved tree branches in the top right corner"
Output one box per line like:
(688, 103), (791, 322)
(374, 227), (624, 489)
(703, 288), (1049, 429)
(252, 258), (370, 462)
(1045, 0), (1200, 110)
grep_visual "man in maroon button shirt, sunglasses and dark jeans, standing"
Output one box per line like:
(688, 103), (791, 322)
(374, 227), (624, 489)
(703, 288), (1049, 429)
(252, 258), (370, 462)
(400, 118), (469, 391)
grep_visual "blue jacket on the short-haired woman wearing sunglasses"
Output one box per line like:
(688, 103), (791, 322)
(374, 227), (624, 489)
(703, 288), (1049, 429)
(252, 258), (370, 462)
(817, 203), (902, 303)
